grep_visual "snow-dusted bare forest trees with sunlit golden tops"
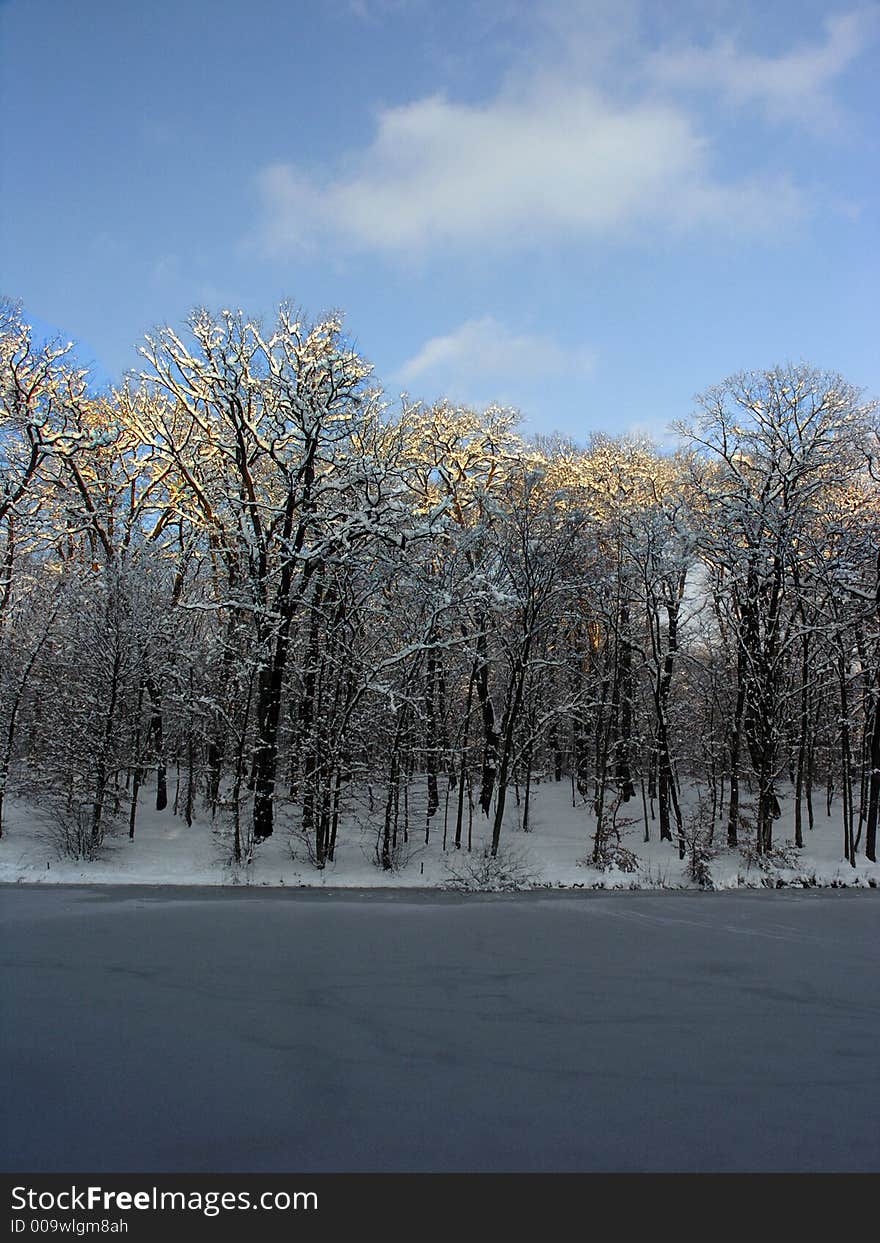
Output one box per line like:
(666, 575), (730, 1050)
(0, 303), (880, 869)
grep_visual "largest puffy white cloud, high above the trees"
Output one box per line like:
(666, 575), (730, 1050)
(259, 78), (797, 255)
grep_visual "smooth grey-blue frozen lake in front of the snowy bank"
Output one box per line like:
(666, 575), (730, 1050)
(0, 886), (880, 1172)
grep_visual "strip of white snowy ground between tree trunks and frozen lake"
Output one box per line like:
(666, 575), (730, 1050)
(0, 782), (880, 890)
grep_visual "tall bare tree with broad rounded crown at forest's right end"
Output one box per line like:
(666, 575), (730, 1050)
(682, 365), (865, 851)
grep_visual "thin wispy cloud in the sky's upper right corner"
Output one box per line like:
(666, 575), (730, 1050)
(649, 7), (880, 128)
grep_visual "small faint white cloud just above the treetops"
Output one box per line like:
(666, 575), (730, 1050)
(394, 316), (595, 400)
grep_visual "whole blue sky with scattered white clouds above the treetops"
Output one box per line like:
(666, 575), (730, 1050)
(0, 0), (880, 440)
